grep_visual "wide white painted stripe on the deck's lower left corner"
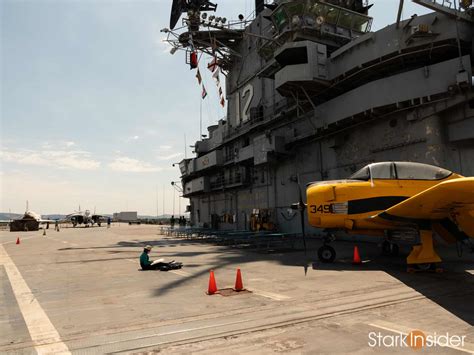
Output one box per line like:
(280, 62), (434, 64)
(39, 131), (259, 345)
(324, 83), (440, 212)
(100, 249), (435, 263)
(0, 245), (70, 354)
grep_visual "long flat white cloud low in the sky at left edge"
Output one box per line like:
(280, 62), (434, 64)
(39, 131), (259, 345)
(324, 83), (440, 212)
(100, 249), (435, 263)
(0, 147), (100, 170)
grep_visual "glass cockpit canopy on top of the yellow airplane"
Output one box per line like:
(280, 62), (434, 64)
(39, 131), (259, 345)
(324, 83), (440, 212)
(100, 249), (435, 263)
(350, 162), (452, 181)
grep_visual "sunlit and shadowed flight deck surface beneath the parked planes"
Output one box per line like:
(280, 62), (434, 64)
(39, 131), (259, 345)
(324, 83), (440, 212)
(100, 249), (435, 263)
(0, 224), (474, 354)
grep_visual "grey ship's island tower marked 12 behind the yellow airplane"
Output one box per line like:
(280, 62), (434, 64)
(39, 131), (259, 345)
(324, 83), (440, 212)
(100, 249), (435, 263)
(170, 0), (474, 233)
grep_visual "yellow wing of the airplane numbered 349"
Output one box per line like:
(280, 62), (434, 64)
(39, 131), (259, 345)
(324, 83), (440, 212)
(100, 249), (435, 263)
(371, 177), (474, 237)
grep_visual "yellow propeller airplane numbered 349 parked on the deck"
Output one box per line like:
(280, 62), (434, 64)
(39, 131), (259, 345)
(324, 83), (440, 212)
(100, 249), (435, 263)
(306, 162), (474, 270)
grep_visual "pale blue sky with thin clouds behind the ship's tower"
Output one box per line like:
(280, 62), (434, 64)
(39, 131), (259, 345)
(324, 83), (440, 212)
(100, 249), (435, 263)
(0, 0), (427, 215)
